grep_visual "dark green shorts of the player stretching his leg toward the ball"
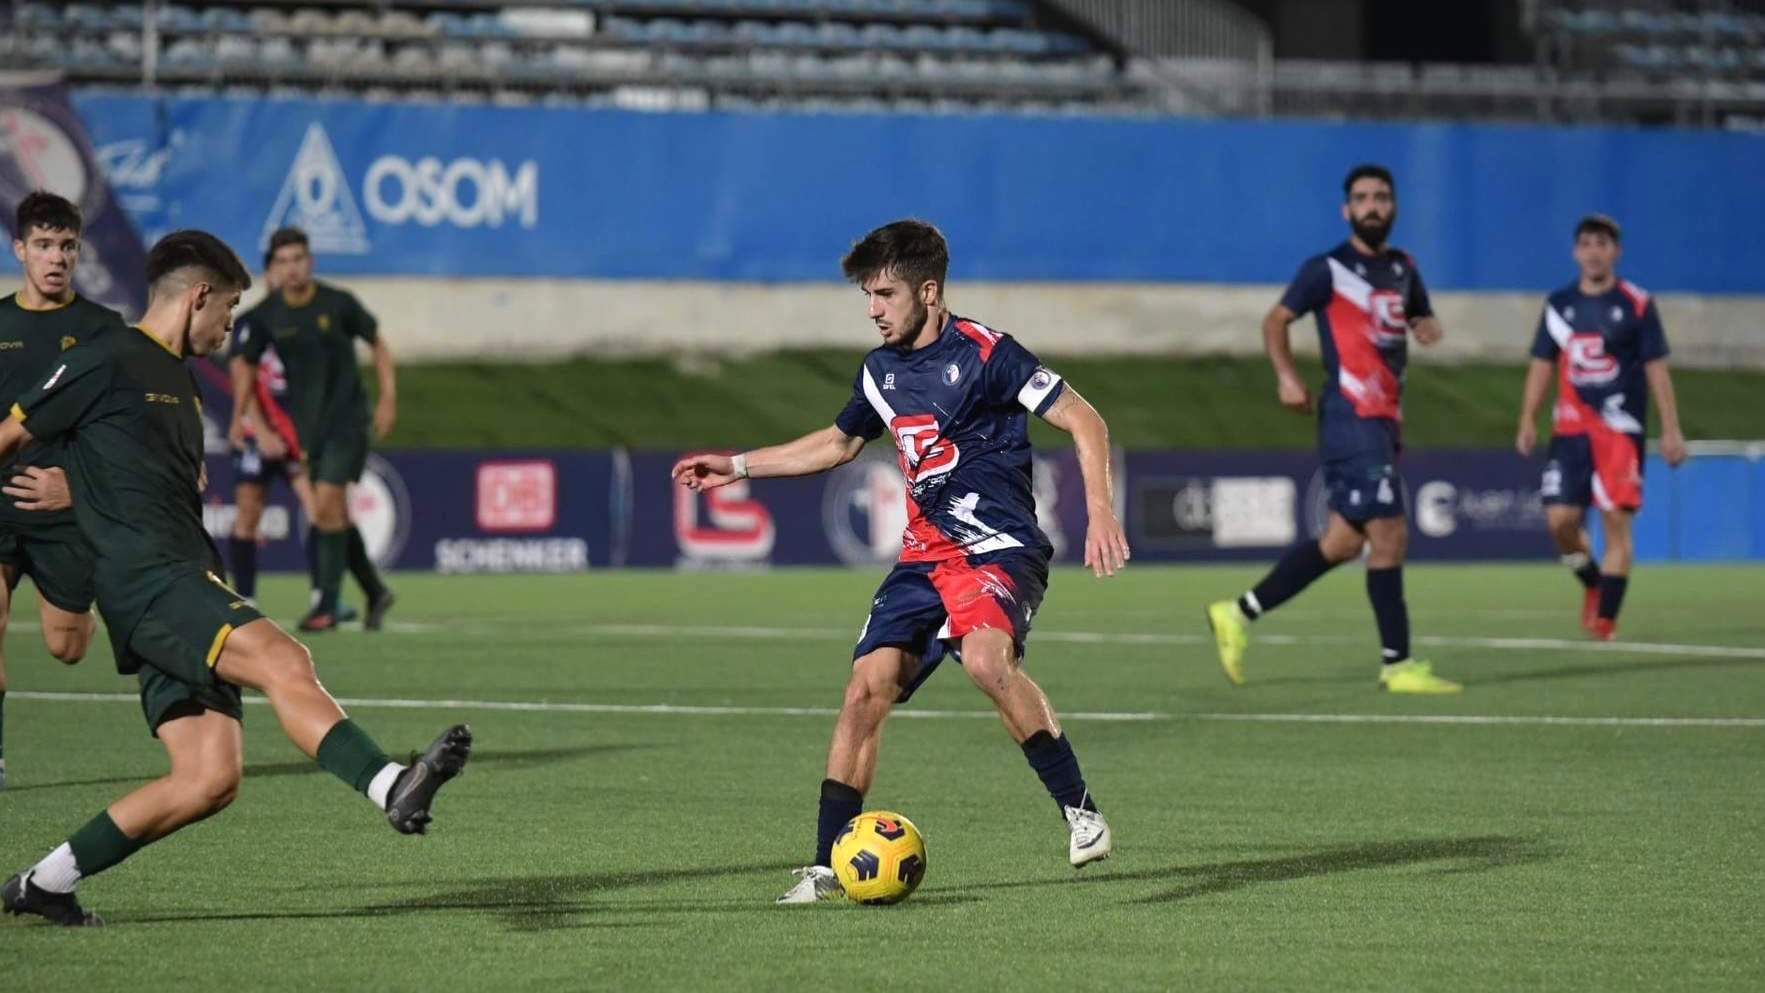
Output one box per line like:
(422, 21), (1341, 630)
(116, 573), (263, 737)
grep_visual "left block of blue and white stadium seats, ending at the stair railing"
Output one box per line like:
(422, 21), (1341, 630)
(7, 0), (1131, 109)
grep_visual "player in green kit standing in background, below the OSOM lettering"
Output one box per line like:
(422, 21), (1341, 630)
(228, 228), (397, 631)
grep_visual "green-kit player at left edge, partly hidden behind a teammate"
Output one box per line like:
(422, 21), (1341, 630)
(0, 190), (122, 787)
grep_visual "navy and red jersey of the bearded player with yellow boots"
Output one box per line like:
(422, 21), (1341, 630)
(1281, 242), (1433, 420)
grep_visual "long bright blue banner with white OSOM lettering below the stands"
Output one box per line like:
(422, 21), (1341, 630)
(68, 93), (1765, 293)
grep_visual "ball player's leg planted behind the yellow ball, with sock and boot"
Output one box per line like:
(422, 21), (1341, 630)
(778, 647), (920, 903)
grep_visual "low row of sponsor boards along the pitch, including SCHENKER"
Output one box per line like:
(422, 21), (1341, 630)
(196, 450), (1765, 573)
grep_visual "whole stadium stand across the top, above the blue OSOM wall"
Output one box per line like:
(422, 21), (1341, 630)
(0, 0), (1765, 125)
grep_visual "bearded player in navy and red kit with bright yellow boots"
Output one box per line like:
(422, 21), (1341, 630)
(1207, 166), (1460, 693)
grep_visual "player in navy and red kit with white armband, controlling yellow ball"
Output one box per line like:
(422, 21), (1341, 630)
(674, 220), (1128, 903)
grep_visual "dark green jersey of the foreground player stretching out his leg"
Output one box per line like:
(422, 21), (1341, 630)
(12, 328), (219, 672)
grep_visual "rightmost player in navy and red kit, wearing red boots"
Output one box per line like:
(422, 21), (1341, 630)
(1514, 215), (1686, 640)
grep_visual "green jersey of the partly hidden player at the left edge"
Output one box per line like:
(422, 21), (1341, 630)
(0, 293), (124, 524)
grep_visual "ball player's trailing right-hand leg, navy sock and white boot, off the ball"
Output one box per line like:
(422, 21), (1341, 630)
(962, 628), (1114, 868)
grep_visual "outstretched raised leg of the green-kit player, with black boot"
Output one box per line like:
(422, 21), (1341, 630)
(215, 617), (471, 834)
